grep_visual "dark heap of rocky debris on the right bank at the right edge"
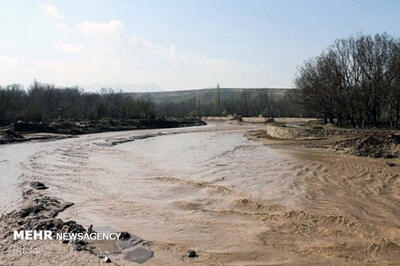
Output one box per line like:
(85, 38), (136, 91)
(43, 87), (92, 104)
(334, 133), (400, 158)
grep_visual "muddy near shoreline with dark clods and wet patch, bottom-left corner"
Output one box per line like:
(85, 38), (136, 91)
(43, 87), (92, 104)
(0, 182), (159, 265)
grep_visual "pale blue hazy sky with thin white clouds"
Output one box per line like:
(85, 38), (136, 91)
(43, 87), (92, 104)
(0, 0), (400, 90)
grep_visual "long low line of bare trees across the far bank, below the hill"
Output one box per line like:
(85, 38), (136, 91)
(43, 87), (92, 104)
(0, 81), (304, 125)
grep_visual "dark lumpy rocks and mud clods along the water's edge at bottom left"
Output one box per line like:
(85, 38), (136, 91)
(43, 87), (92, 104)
(0, 182), (154, 263)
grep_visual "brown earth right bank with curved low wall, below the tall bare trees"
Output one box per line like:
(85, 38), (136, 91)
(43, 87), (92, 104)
(247, 122), (400, 158)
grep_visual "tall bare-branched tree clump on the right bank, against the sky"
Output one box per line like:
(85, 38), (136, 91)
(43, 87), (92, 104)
(295, 33), (400, 127)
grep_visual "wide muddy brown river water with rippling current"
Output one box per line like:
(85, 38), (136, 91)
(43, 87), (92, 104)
(0, 122), (400, 265)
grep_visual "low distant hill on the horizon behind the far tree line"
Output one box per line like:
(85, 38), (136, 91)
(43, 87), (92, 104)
(132, 88), (292, 104)
